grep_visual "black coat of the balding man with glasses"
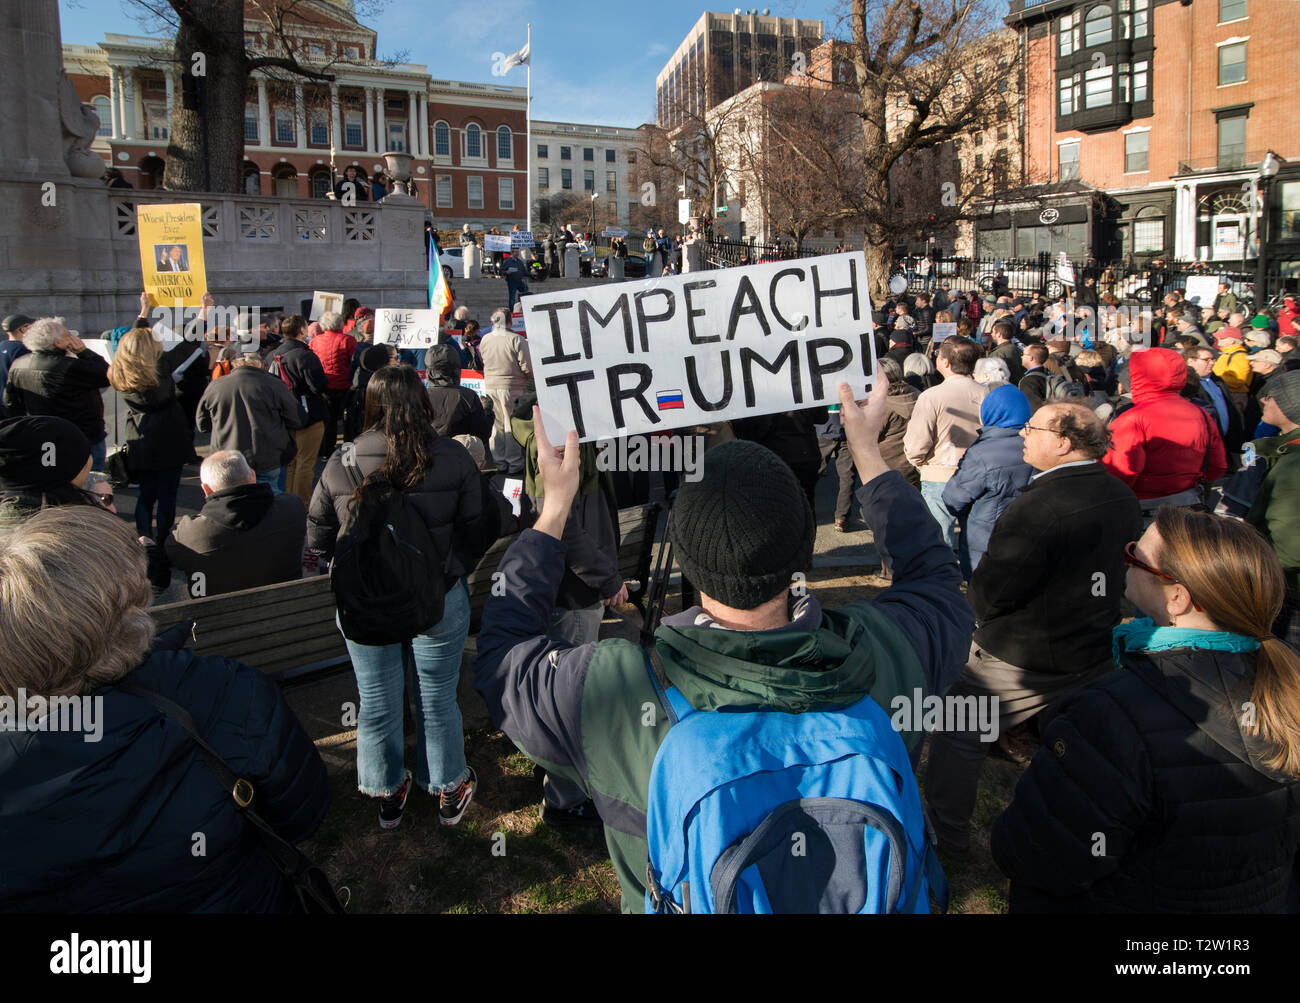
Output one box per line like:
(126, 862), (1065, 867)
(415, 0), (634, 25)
(967, 463), (1141, 673)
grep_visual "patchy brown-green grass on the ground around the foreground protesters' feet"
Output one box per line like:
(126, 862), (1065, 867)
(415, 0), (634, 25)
(304, 568), (1022, 913)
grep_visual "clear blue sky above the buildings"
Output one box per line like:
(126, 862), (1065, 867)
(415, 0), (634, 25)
(59, 0), (840, 126)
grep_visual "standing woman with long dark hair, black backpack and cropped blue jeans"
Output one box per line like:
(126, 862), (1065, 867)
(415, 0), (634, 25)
(307, 365), (485, 829)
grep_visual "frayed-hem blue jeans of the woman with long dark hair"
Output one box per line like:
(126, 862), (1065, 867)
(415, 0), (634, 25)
(347, 578), (469, 798)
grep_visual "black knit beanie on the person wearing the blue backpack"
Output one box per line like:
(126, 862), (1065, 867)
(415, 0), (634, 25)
(668, 439), (816, 609)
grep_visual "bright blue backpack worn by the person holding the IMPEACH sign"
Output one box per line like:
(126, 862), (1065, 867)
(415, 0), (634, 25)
(645, 648), (948, 913)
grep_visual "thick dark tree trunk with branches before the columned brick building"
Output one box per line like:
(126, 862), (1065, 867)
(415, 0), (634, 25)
(131, 0), (387, 194)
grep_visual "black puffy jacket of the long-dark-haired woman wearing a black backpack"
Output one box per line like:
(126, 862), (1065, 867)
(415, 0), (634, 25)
(307, 429), (490, 586)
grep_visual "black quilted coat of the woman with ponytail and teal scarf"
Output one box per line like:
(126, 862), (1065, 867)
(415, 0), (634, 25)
(991, 648), (1300, 912)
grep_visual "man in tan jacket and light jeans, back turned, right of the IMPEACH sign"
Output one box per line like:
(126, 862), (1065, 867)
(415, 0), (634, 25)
(902, 335), (988, 551)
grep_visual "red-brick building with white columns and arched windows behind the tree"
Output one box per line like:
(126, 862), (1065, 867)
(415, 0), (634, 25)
(64, 0), (528, 226)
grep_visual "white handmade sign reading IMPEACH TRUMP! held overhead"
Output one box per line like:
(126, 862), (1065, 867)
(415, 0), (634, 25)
(523, 251), (875, 443)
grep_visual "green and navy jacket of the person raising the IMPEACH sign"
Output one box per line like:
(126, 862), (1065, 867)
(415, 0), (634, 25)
(475, 472), (974, 912)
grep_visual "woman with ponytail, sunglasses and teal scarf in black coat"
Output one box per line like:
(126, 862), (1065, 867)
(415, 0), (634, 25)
(991, 505), (1300, 912)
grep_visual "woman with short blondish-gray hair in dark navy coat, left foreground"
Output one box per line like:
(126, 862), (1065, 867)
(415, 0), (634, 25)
(0, 505), (329, 913)
